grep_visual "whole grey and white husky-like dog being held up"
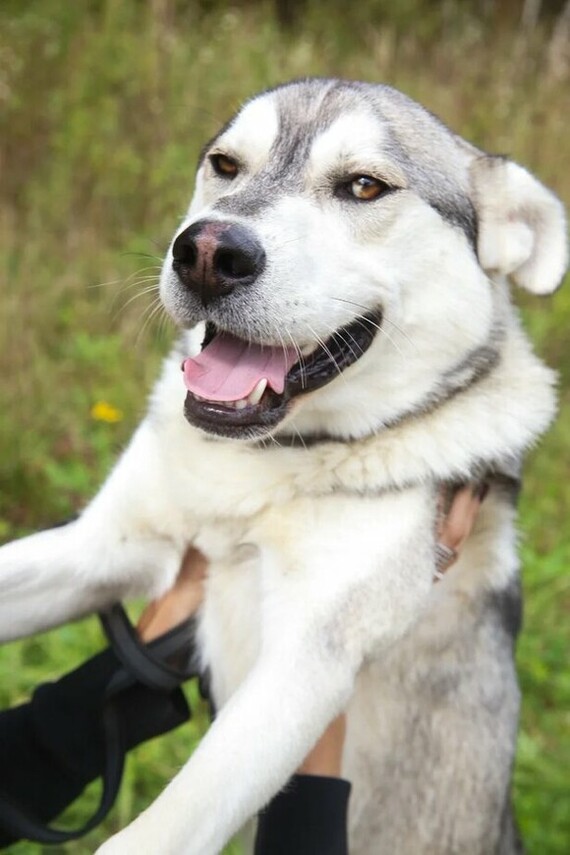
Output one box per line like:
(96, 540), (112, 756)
(0, 79), (567, 855)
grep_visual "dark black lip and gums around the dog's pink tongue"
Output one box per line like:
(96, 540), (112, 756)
(184, 309), (382, 439)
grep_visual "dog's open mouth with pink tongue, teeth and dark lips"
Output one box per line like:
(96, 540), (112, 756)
(182, 311), (382, 439)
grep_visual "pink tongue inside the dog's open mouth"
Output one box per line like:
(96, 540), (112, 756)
(183, 333), (297, 401)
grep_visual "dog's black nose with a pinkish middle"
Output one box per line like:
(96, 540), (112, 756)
(172, 220), (265, 306)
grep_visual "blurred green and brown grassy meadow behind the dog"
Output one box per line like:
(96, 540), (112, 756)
(0, 0), (570, 855)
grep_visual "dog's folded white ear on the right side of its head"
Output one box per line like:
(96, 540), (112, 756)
(471, 155), (568, 294)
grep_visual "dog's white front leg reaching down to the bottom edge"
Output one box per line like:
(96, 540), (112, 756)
(99, 490), (433, 855)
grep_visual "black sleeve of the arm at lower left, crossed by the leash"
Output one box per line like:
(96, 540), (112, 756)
(0, 649), (189, 847)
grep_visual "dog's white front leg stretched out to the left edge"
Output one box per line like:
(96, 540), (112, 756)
(0, 423), (185, 641)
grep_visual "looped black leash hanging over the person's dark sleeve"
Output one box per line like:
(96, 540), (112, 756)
(0, 603), (199, 844)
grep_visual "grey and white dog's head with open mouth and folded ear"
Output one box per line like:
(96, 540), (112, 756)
(161, 80), (567, 439)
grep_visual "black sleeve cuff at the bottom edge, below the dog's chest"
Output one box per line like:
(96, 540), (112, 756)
(254, 775), (350, 855)
